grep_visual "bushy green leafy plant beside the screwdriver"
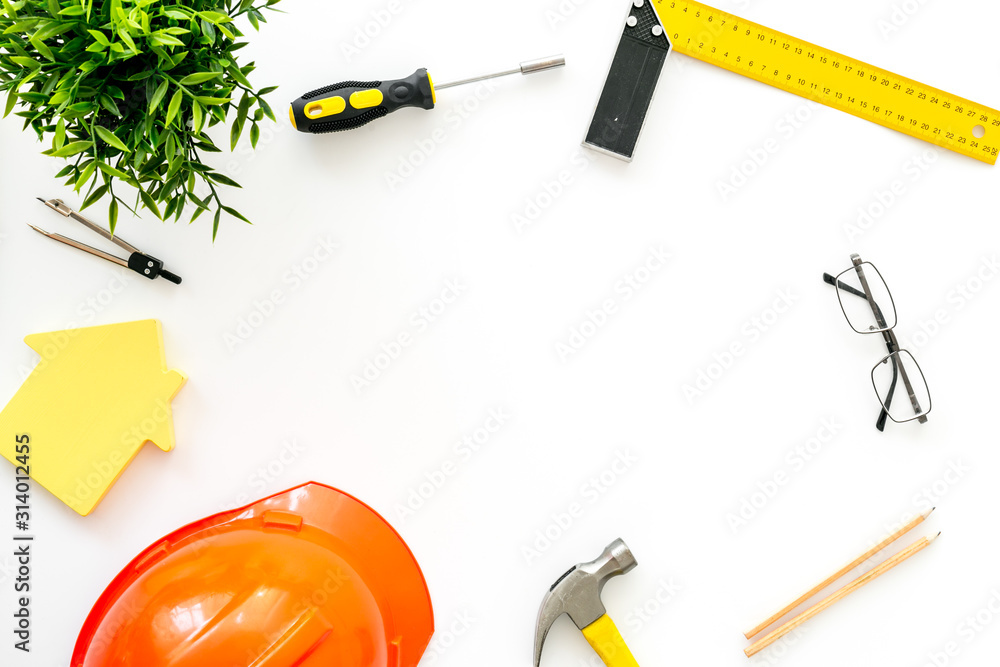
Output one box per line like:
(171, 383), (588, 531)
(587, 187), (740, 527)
(0, 0), (280, 239)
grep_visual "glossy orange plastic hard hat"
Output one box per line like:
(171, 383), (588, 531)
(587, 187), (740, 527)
(71, 482), (434, 667)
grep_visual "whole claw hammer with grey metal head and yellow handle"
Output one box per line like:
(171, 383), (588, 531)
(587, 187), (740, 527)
(535, 539), (639, 667)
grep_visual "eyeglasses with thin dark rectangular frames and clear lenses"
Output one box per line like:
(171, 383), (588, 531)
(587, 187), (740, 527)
(823, 255), (931, 431)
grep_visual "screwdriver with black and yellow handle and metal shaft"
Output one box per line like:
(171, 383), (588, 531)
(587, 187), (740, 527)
(288, 55), (566, 134)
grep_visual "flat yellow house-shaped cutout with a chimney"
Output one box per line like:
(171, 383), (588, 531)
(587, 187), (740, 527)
(0, 320), (187, 516)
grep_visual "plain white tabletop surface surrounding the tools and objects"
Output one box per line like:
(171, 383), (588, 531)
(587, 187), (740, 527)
(0, 0), (1000, 667)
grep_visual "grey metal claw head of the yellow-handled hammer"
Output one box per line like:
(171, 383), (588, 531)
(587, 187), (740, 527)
(535, 539), (638, 667)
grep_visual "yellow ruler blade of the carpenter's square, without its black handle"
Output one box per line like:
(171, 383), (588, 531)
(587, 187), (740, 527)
(653, 0), (1000, 164)
